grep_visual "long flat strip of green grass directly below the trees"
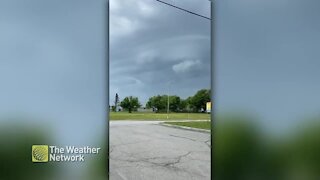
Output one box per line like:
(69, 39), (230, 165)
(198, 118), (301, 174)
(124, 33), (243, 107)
(110, 112), (210, 120)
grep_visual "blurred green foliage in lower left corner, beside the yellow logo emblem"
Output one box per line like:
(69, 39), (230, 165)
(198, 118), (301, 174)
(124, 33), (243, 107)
(0, 119), (58, 180)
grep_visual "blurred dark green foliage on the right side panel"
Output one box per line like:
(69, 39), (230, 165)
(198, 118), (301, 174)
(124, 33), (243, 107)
(212, 115), (320, 180)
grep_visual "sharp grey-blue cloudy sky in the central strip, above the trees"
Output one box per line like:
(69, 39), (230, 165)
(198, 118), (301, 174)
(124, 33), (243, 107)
(110, 0), (210, 105)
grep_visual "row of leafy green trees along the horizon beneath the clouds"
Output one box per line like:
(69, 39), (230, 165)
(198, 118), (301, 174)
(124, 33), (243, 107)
(112, 89), (211, 113)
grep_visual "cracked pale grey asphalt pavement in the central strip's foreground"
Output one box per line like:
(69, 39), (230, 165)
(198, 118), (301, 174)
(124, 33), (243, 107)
(110, 121), (211, 180)
